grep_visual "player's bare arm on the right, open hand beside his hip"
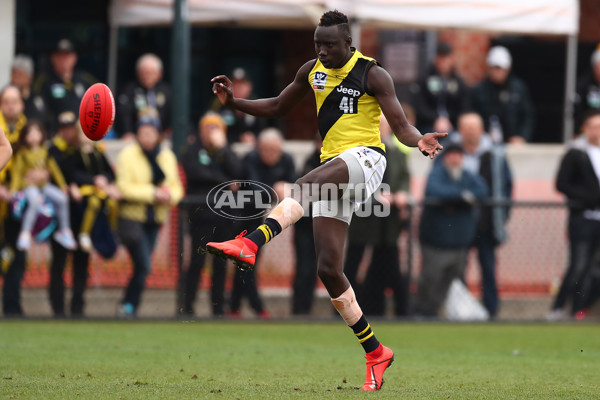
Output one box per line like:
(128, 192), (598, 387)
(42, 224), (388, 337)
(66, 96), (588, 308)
(367, 65), (448, 158)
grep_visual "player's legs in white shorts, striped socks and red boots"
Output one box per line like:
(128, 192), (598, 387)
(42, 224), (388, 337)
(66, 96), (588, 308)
(207, 149), (394, 391)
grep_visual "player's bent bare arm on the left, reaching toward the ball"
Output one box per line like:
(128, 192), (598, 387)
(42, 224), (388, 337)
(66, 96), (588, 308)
(211, 60), (314, 118)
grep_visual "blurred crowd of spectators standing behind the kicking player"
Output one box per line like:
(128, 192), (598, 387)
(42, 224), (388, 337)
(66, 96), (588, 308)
(0, 39), (600, 318)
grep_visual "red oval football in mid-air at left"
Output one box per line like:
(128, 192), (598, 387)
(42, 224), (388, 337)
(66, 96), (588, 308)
(79, 83), (115, 140)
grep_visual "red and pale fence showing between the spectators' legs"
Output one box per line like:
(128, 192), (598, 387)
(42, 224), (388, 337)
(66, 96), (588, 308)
(2, 197), (584, 320)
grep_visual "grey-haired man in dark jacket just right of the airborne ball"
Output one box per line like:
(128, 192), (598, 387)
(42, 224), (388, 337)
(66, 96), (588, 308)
(116, 53), (172, 139)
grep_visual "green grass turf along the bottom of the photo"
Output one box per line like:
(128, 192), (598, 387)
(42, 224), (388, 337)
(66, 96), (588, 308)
(0, 321), (600, 399)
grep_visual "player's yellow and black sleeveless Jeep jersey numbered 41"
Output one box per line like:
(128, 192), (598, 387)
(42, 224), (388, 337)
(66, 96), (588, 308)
(308, 49), (385, 161)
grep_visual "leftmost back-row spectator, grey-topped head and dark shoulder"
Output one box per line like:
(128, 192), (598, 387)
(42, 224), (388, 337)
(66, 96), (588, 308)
(10, 54), (46, 121)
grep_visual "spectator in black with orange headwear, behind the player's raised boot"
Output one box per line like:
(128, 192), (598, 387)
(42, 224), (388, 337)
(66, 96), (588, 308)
(179, 112), (243, 316)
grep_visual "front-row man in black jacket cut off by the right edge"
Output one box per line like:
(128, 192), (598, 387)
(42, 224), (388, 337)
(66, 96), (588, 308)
(548, 111), (600, 319)
